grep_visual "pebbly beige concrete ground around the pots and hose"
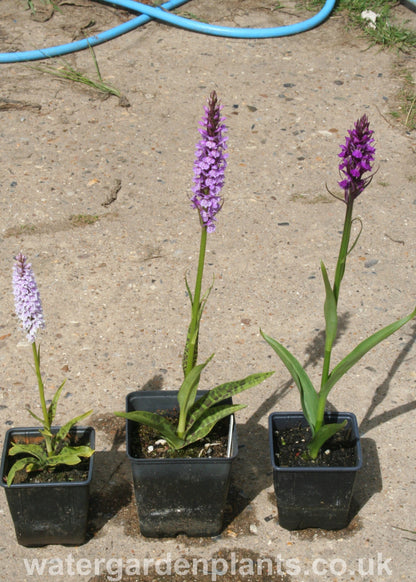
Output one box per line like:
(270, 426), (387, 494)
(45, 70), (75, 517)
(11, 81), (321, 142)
(0, 0), (416, 582)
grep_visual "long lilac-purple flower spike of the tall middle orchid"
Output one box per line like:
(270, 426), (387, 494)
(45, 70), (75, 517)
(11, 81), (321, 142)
(191, 91), (228, 232)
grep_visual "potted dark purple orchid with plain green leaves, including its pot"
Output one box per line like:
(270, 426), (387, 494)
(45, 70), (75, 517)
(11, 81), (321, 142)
(261, 115), (416, 529)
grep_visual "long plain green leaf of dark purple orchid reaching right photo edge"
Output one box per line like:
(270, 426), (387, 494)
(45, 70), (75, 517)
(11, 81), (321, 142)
(322, 309), (416, 402)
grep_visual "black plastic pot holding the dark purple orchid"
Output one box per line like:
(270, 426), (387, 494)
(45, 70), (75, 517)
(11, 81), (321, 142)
(269, 412), (362, 530)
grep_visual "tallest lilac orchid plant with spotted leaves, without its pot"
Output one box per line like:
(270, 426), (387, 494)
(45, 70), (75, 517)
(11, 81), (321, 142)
(115, 91), (273, 449)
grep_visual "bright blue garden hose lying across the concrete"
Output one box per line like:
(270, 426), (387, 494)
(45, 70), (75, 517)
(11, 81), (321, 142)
(0, 0), (336, 63)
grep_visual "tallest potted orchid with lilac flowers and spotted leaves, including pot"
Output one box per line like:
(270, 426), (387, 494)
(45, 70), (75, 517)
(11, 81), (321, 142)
(116, 91), (272, 537)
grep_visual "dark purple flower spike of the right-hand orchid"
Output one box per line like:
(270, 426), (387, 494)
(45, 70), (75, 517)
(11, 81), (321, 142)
(338, 115), (376, 203)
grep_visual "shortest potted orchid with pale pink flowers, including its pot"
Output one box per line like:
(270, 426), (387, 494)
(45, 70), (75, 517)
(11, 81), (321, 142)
(1, 253), (95, 546)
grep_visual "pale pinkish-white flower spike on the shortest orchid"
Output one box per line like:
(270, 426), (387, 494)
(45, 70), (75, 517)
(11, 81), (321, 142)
(13, 253), (45, 343)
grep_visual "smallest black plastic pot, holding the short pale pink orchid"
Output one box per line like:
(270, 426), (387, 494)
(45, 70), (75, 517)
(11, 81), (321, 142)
(1, 427), (95, 546)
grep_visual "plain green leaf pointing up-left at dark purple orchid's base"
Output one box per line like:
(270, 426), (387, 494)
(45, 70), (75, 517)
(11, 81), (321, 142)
(260, 330), (319, 431)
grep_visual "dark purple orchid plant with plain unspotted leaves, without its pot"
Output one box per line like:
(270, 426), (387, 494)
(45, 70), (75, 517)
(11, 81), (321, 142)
(261, 115), (416, 459)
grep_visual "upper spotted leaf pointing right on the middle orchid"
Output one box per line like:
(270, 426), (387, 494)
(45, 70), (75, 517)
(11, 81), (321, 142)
(186, 372), (274, 432)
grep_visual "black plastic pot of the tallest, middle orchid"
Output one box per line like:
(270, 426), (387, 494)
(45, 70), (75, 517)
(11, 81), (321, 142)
(126, 390), (238, 537)
